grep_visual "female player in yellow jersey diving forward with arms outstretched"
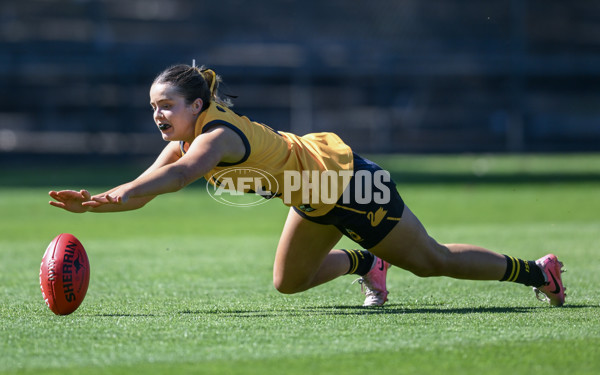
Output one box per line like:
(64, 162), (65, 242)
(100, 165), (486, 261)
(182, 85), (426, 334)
(49, 65), (565, 306)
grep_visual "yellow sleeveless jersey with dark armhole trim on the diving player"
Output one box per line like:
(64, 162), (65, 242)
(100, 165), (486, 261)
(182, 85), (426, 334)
(181, 102), (354, 216)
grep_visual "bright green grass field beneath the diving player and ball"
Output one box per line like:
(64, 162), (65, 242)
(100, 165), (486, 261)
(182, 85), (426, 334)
(0, 155), (600, 375)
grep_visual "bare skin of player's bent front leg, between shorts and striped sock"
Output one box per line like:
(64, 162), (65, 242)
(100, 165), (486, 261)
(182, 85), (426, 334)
(273, 209), (350, 293)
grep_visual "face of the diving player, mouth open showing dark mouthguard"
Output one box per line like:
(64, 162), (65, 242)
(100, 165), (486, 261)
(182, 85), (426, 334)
(150, 83), (202, 143)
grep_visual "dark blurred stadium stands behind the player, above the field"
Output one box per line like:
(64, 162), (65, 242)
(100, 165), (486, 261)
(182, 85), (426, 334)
(0, 0), (600, 165)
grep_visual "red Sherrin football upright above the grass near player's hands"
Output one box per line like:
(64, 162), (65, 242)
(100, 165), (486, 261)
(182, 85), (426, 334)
(40, 233), (90, 315)
